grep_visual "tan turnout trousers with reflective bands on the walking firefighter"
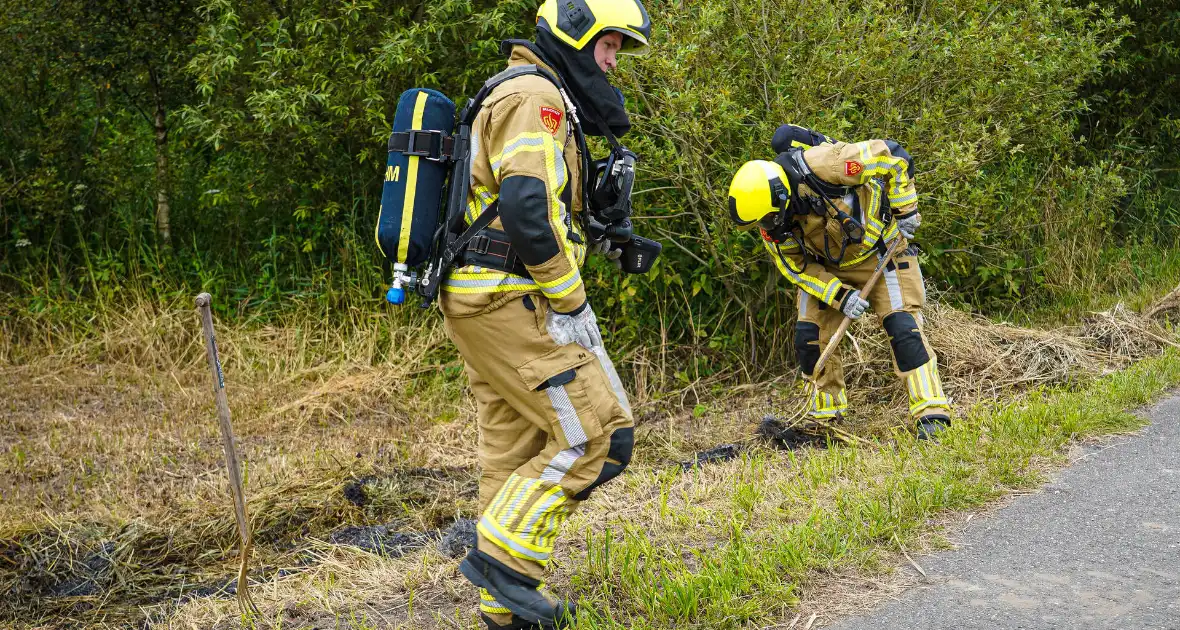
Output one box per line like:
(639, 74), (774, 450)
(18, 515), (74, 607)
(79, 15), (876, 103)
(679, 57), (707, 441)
(446, 293), (634, 623)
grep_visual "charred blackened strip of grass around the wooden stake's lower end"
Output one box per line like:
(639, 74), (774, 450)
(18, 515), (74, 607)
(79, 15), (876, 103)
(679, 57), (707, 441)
(0, 466), (478, 626)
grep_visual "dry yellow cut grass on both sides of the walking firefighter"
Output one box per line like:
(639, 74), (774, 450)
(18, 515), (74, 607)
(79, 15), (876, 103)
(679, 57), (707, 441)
(0, 290), (1172, 628)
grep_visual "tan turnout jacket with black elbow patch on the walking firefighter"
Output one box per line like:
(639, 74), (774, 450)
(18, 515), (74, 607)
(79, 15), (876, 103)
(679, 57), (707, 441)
(440, 46), (586, 317)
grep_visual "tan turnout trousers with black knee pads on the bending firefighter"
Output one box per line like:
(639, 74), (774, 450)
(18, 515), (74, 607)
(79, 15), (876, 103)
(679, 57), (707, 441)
(795, 252), (950, 419)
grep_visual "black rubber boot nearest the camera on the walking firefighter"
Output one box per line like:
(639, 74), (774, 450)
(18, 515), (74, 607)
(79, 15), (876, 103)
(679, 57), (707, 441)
(459, 549), (575, 630)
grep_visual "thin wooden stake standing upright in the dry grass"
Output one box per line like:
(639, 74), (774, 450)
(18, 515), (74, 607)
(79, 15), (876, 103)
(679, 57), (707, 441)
(197, 293), (258, 615)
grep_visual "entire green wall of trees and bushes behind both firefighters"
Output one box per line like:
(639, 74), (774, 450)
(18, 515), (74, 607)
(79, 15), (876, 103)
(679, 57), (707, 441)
(0, 0), (1180, 379)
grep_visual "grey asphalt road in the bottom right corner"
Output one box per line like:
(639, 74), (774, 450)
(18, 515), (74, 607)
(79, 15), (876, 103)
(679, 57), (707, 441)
(830, 396), (1180, 630)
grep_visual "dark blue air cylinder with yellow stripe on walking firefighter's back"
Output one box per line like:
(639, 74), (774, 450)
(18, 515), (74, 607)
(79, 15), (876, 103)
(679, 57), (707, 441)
(376, 87), (455, 304)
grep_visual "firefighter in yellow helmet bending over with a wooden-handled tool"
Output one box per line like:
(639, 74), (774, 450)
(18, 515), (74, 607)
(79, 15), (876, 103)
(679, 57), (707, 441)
(729, 125), (950, 438)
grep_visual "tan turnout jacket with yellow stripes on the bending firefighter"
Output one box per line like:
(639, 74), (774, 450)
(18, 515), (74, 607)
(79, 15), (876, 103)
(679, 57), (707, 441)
(762, 139), (918, 306)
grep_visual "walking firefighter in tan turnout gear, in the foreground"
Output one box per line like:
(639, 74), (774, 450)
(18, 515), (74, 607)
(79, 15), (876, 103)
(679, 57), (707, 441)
(440, 0), (650, 629)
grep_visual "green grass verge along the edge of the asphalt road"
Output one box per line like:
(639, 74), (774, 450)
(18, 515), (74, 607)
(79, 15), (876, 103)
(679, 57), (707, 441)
(559, 350), (1180, 630)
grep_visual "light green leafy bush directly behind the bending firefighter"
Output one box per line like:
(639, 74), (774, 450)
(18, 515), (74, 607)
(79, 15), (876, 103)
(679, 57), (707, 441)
(608, 0), (1125, 370)
